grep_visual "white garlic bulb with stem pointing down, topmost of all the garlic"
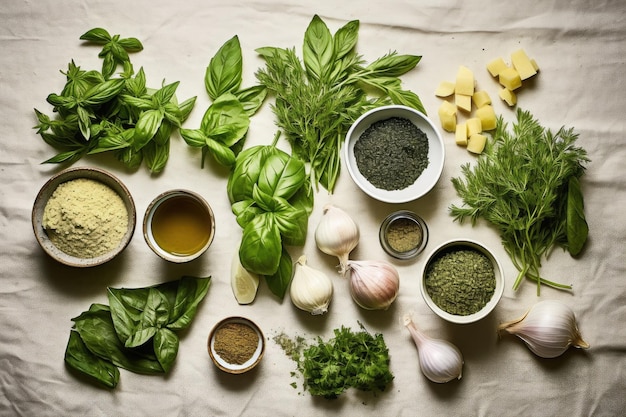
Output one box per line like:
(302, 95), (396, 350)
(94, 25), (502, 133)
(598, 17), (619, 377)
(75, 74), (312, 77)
(315, 204), (359, 275)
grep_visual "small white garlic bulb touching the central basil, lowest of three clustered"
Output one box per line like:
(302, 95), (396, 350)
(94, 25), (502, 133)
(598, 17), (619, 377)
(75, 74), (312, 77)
(289, 255), (333, 315)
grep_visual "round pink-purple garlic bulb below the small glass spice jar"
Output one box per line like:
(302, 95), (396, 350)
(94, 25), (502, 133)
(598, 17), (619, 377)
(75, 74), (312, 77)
(347, 261), (400, 310)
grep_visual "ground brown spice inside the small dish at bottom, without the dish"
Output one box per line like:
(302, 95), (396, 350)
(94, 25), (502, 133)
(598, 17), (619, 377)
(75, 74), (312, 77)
(213, 323), (259, 365)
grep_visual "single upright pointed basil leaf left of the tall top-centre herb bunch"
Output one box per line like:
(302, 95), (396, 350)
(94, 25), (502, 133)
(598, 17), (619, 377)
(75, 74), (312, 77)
(204, 36), (243, 100)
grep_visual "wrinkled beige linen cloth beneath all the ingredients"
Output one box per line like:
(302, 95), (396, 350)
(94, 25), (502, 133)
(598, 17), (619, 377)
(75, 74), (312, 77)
(0, 0), (626, 417)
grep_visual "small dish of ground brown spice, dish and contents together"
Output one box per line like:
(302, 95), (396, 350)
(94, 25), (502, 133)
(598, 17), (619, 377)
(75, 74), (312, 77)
(208, 316), (265, 374)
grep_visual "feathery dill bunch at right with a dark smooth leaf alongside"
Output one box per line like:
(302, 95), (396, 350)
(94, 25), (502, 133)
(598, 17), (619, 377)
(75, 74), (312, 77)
(450, 109), (589, 295)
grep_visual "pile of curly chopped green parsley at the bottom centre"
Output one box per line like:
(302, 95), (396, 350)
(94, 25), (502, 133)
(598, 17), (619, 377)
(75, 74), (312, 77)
(274, 325), (394, 399)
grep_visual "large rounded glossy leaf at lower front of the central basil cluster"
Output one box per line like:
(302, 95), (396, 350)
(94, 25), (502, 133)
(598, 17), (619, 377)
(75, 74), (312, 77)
(239, 213), (282, 275)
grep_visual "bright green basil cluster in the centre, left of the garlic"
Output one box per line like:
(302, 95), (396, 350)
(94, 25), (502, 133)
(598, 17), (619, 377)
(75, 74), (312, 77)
(227, 139), (313, 299)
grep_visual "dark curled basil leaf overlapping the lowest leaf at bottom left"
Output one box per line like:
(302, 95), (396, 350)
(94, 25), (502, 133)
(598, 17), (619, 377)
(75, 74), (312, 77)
(72, 306), (163, 374)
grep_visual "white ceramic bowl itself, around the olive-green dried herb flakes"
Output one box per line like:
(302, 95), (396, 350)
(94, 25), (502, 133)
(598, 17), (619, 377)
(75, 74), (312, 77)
(420, 239), (504, 324)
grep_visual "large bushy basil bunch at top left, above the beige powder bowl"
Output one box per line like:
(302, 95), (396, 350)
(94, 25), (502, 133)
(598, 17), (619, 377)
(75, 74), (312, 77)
(35, 28), (196, 173)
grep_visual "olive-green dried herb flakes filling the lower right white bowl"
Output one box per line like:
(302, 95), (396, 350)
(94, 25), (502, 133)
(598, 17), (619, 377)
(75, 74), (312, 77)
(425, 248), (496, 316)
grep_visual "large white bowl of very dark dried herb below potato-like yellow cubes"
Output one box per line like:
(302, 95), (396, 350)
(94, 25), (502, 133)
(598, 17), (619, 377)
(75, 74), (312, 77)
(343, 105), (445, 203)
